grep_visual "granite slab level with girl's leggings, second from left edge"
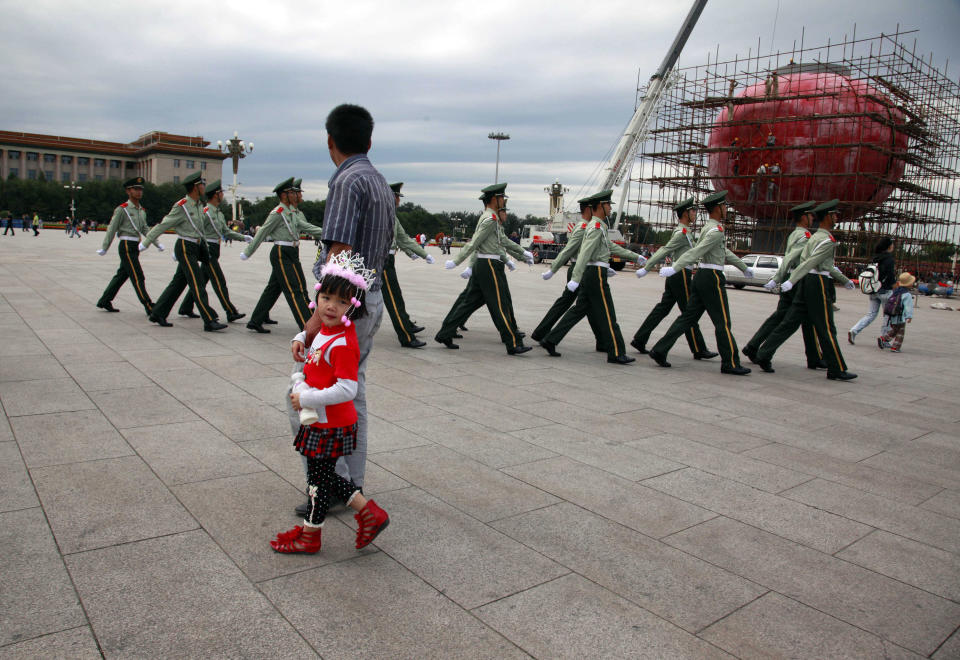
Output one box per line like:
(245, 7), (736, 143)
(31, 456), (197, 554)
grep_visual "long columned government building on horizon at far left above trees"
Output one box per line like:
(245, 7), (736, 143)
(0, 131), (228, 183)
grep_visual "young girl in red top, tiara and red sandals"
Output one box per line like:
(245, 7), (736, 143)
(270, 252), (390, 554)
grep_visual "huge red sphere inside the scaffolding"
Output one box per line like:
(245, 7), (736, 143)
(708, 65), (907, 219)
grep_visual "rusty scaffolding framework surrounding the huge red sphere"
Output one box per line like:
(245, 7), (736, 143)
(627, 27), (960, 275)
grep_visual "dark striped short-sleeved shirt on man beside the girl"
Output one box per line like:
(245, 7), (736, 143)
(313, 154), (396, 291)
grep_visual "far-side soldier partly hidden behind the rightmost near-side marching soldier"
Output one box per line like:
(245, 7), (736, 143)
(743, 202), (827, 369)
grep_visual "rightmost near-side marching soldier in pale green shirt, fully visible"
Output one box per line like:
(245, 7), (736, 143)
(756, 199), (857, 380)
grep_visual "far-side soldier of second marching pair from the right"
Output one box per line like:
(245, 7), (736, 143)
(630, 197), (717, 360)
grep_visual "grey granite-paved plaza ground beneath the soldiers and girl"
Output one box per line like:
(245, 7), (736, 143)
(0, 230), (960, 659)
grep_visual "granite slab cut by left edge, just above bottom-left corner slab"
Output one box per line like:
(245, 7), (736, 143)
(0, 507), (86, 646)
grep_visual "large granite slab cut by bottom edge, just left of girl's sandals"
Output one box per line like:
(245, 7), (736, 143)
(66, 530), (315, 658)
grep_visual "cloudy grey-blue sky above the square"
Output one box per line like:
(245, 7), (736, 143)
(0, 0), (960, 215)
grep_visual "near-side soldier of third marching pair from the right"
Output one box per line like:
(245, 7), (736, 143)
(540, 190), (643, 364)
